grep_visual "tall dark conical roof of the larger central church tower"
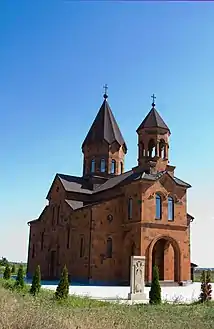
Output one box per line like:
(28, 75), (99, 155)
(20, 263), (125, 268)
(82, 99), (127, 150)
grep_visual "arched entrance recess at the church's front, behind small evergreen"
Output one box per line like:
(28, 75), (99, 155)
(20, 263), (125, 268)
(148, 236), (180, 282)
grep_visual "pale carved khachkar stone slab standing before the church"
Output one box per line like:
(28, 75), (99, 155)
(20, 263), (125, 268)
(128, 256), (146, 301)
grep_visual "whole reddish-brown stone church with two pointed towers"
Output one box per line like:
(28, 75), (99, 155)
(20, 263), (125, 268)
(27, 88), (193, 284)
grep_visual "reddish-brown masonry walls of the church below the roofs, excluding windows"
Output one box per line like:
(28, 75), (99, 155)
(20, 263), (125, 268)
(28, 172), (190, 282)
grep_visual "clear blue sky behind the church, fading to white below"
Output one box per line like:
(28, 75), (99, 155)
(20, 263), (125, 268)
(0, 0), (214, 266)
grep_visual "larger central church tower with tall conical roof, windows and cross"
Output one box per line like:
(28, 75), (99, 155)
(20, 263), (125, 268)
(82, 85), (127, 178)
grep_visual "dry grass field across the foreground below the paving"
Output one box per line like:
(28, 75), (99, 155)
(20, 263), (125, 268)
(0, 282), (214, 329)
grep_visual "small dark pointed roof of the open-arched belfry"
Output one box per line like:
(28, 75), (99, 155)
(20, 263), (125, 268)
(137, 107), (170, 132)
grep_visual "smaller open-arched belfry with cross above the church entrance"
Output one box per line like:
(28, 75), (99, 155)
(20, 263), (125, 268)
(137, 94), (170, 172)
